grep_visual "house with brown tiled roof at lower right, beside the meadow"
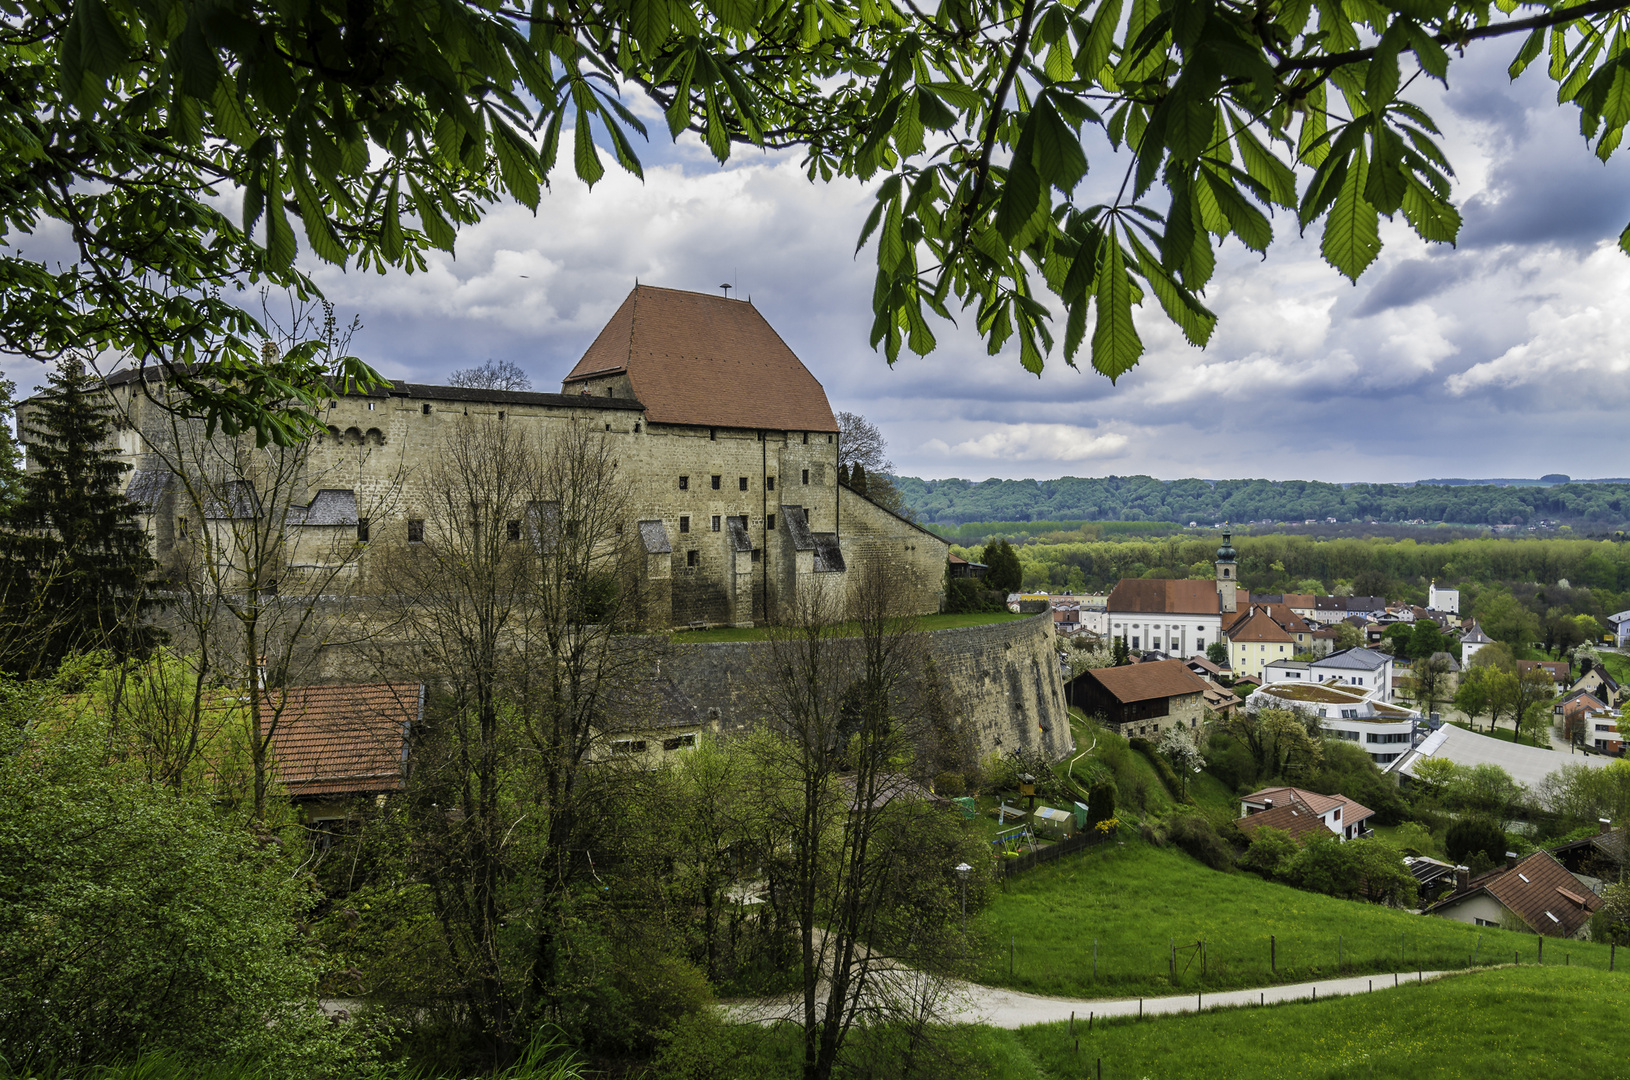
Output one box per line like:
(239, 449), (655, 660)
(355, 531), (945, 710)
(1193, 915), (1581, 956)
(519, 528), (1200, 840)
(1425, 852), (1602, 938)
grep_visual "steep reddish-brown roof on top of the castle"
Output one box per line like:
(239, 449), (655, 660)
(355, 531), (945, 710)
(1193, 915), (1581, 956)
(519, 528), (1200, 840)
(561, 285), (838, 432)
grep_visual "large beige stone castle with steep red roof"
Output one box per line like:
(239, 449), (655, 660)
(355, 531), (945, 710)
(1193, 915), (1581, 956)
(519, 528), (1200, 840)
(82, 285), (949, 627)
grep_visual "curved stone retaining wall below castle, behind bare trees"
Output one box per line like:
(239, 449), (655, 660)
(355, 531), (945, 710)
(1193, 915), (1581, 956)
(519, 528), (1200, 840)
(662, 614), (1073, 761)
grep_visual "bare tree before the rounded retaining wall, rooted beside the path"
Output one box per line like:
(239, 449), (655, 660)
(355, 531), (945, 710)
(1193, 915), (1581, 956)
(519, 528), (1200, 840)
(753, 570), (988, 1080)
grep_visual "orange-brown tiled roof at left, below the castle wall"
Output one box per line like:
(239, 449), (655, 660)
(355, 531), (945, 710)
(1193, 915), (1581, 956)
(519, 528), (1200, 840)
(261, 683), (421, 798)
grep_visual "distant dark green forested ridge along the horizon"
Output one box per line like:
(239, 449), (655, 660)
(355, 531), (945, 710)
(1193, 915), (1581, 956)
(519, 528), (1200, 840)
(897, 476), (1630, 533)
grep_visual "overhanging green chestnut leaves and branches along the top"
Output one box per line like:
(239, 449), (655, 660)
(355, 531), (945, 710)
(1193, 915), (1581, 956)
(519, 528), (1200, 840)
(9, 0), (1630, 441)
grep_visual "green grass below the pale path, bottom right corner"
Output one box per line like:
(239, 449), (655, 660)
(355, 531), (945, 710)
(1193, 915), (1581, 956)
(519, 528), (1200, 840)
(963, 968), (1630, 1080)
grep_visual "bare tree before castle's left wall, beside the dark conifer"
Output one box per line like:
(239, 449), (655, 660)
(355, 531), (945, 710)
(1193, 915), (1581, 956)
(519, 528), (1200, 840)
(105, 298), (403, 819)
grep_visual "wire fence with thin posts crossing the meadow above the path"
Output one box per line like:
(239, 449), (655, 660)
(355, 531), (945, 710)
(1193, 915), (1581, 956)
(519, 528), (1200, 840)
(983, 924), (1630, 997)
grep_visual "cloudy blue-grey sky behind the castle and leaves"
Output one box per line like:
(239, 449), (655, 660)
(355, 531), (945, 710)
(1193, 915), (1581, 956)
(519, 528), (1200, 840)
(16, 41), (1630, 481)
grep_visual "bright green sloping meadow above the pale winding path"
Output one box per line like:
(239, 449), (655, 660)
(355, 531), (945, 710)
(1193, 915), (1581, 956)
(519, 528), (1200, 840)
(970, 829), (1607, 997)
